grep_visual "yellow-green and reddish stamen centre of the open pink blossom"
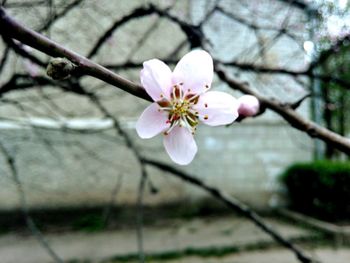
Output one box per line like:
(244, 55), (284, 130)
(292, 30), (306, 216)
(158, 83), (199, 135)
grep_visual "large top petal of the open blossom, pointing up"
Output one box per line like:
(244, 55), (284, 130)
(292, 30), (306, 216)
(173, 50), (214, 94)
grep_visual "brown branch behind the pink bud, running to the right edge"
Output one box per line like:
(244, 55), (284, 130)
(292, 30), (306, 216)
(216, 68), (350, 155)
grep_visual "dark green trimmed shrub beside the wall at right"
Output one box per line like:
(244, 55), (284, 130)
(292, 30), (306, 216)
(281, 161), (350, 221)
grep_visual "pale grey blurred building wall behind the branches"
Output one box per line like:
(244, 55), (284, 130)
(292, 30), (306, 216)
(0, 0), (313, 209)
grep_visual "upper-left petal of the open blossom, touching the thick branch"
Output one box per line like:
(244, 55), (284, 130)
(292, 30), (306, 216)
(140, 59), (172, 101)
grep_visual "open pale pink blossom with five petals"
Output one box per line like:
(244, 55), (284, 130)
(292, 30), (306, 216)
(136, 50), (238, 165)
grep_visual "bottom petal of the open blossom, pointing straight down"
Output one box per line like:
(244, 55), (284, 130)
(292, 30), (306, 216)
(164, 126), (197, 165)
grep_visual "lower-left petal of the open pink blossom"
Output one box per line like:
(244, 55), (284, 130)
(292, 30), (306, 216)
(136, 103), (170, 139)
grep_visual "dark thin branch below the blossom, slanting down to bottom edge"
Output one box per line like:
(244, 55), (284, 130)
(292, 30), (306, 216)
(142, 158), (316, 263)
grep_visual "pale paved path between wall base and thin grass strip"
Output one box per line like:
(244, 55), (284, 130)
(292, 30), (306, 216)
(0, 218), (336, 263)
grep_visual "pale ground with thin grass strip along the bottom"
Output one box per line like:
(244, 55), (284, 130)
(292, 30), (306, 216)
(0, 216), (350, 263)
